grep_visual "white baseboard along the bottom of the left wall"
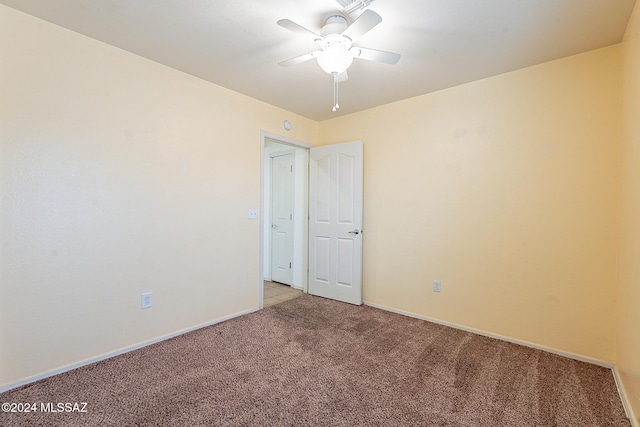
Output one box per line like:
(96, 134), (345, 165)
(0, 308), (259, 393)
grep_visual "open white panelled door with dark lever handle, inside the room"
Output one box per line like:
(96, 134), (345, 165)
(309, 141), (363, 305)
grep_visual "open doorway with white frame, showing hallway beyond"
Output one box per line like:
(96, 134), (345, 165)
(260, 133), (311, 308)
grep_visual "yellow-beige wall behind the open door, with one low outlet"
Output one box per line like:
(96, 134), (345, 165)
(320, 46), (622, 362)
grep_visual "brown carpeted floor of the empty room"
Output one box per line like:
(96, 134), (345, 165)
(0, 295), (630, 427)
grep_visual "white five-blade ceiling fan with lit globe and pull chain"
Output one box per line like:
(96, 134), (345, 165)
(278, 9), (400, 111)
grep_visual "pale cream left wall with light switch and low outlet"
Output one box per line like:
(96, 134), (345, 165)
(0, 5), (318, 386)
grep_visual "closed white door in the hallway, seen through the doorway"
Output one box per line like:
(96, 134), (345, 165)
(271, 152), (294, 286)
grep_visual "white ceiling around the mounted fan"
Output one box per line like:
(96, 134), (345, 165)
(0, 0), (635, 121)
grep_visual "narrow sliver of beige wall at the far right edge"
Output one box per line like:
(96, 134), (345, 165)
(617, 3), (640, 425)
